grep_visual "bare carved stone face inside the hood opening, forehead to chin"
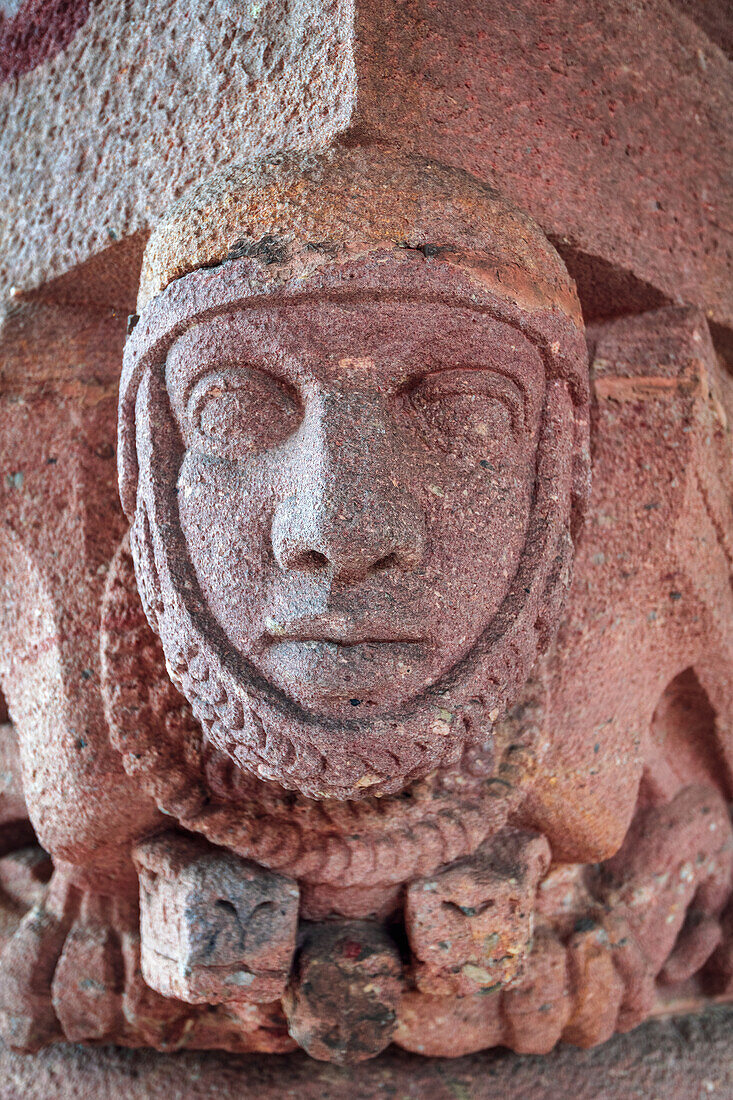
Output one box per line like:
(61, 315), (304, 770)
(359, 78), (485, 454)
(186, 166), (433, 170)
(165, 298), (545, 718)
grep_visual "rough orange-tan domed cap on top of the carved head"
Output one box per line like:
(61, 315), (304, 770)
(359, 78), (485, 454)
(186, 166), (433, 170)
(132, 143), (580, 314)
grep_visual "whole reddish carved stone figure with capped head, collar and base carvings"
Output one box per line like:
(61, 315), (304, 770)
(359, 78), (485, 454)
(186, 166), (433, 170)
(0, 144), (733, 1062)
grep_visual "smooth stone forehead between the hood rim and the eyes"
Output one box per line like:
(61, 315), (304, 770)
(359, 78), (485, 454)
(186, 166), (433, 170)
(167, 298), (544, 388)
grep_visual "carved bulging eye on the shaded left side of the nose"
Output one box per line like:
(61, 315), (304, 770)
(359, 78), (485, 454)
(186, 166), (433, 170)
(186, 367), (300, 461)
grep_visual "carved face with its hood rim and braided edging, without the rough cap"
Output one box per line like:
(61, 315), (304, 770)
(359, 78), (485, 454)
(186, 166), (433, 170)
(120, 250), (587, 799)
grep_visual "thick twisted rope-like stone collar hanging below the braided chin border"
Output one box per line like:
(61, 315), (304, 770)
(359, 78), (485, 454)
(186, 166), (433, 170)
(101, 538), (550, 888)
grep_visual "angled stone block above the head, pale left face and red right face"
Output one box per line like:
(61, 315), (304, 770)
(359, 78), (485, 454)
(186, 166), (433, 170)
(0, 0), (733, 345)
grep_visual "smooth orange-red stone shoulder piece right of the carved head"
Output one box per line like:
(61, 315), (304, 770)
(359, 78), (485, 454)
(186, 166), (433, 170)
(519, 309), (733, 861)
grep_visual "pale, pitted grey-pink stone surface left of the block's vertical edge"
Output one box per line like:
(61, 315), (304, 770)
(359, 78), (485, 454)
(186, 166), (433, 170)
(0, 0), (354, 301)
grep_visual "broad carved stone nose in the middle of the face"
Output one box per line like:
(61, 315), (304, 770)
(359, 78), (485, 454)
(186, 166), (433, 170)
(272, 398), (426, 581)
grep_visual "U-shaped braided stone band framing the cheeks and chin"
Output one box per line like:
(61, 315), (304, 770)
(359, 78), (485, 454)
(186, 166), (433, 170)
(125, 365), (572, 800)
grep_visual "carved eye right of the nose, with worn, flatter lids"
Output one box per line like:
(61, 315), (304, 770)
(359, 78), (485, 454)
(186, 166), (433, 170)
(408, 370), (525, 453)
